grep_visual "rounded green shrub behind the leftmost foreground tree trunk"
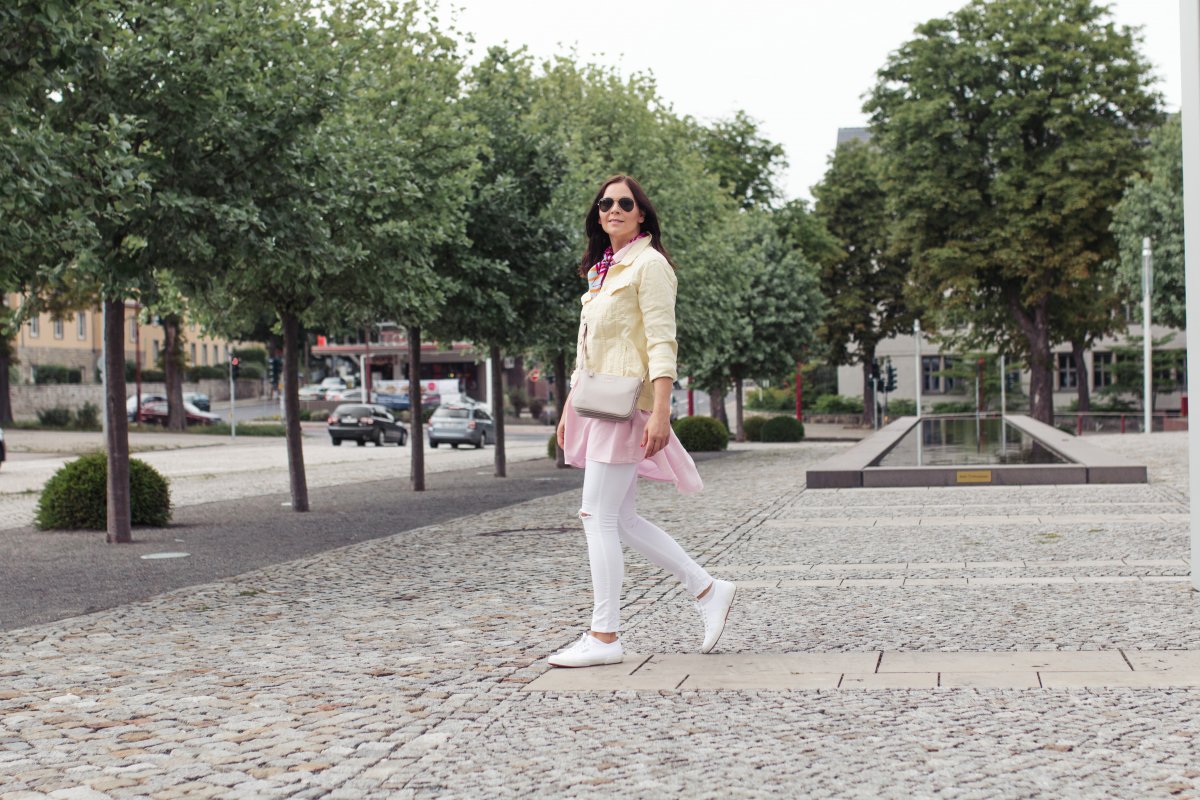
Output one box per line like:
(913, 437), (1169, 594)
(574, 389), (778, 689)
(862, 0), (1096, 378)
(35, 452), (170, 530)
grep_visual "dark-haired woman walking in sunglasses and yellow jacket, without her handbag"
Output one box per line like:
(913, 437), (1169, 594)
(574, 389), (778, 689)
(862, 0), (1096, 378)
(550, 175), (736, 667)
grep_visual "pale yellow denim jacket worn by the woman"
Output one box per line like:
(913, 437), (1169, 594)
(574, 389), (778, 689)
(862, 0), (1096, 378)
(571, 236), (679, 411)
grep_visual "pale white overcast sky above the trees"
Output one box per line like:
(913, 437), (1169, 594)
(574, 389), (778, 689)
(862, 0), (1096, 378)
(439, 0), (1180, 198)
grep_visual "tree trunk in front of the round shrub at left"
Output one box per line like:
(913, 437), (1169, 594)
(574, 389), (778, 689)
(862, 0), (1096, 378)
(104, 300), (133, 543)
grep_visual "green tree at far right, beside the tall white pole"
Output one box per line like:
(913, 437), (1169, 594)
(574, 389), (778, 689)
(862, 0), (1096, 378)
(1112, 114), (1187, 329)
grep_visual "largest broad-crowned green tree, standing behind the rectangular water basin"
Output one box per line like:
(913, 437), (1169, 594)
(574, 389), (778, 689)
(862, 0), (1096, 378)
(865, 0), (1158, 422)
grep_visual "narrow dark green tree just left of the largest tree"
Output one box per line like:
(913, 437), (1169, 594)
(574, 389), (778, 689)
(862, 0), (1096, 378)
(812, 142), (914, 425)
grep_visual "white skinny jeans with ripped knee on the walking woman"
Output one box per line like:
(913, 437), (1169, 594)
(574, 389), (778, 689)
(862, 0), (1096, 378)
(580, 458), (713, 633)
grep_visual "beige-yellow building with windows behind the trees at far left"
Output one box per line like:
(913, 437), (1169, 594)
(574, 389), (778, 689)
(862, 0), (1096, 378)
(7, 295), (234, 384)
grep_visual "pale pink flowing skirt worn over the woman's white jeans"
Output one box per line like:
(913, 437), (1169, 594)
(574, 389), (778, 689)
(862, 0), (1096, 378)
(563, 403), (704, 494)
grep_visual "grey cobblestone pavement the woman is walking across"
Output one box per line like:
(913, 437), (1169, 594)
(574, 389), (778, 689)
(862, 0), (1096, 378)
(0, 434), (1200, 798)
